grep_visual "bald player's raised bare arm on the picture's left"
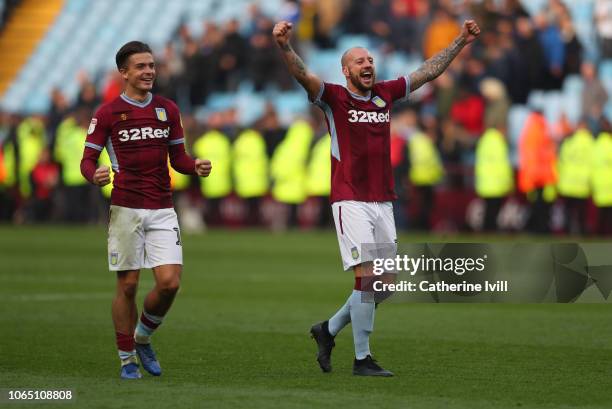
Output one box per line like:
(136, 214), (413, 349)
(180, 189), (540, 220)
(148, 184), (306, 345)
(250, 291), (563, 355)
(272, 21), (321, 101)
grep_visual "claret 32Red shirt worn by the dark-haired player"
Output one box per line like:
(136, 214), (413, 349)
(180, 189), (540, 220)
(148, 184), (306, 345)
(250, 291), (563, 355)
(85, 93), (194, 209)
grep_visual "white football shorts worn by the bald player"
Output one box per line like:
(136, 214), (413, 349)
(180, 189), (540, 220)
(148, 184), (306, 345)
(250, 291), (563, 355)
(332, 200), (397, 270)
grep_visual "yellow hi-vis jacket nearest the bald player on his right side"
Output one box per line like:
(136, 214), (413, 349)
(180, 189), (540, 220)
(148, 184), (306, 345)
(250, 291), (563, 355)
(408, 132), (444, 186)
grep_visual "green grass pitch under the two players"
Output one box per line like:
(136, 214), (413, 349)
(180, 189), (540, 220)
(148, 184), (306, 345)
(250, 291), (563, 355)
(0, 227), (612, 409)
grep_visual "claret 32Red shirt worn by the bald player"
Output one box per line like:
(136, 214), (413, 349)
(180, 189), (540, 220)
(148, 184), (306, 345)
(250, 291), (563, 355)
(313, 77), (410, 203)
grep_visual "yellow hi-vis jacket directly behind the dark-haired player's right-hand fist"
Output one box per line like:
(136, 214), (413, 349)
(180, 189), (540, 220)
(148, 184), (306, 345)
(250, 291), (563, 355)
(193, 130), (232, 199)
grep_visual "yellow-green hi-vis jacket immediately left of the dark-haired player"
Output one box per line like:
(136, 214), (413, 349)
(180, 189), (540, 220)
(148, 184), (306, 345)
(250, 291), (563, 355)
(54, 117), (87, 186)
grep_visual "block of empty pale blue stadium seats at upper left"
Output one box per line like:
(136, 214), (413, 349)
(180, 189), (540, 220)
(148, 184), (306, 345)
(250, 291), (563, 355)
(2, 0), (194, 113)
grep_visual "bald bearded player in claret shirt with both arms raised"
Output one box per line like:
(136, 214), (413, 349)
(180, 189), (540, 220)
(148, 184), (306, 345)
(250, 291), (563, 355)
(273, 20), (480, 376)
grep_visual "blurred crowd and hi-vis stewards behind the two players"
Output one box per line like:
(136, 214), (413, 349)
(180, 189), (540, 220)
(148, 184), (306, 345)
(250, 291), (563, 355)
(0, 0), (612, 234)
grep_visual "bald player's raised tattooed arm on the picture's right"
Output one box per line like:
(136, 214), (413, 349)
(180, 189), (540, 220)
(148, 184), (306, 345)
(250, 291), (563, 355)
(410, 20), (480, 91)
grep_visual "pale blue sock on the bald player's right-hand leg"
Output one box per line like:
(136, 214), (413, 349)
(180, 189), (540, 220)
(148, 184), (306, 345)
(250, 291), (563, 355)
(349, 290), (375, 359)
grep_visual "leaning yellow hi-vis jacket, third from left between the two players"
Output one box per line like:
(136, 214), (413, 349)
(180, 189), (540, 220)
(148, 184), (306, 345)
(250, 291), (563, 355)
(270, 120), (313, 204)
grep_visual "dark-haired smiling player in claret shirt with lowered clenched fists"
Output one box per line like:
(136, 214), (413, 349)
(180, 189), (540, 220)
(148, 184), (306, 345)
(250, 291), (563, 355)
(81, 41), (212, 379)
